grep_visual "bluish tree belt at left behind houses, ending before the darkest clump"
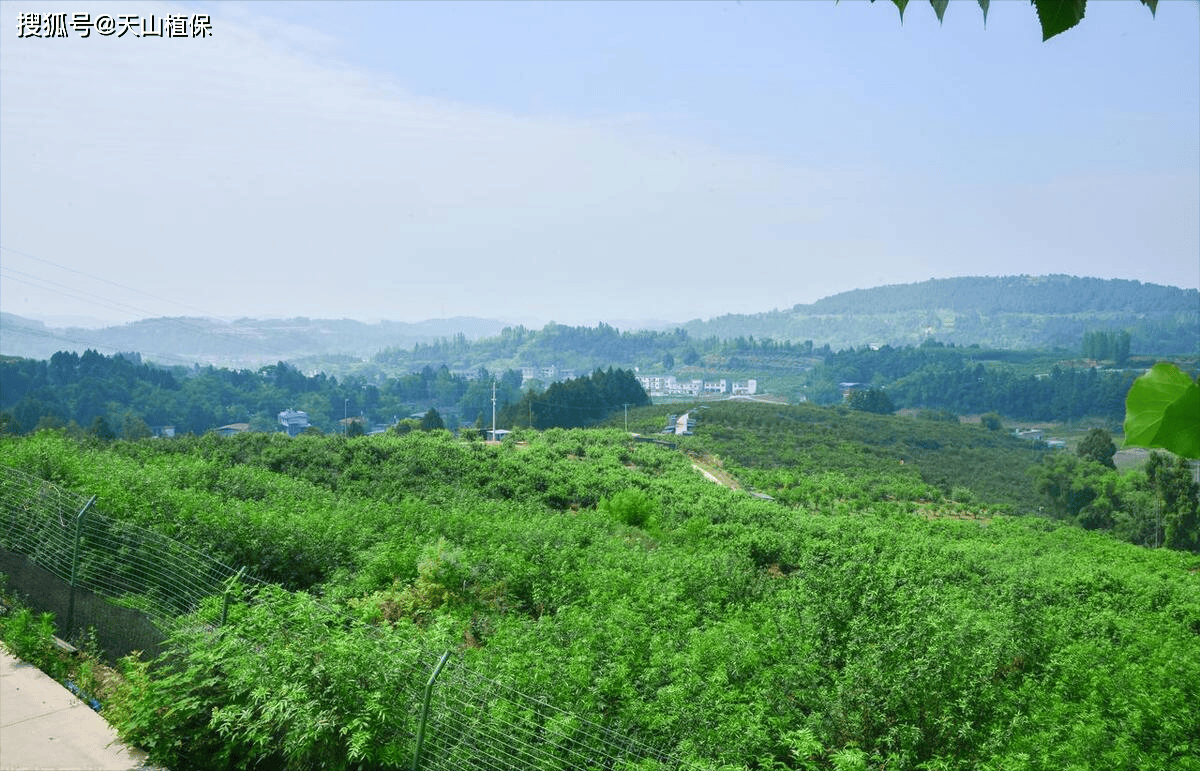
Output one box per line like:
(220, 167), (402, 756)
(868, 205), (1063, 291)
(0, 349), (521, 438)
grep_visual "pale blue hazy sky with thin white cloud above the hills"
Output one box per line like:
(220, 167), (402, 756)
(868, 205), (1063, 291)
(0, 0), (1200, 324)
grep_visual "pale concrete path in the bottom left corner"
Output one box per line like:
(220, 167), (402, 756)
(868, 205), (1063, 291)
(0, 649), (146, 771)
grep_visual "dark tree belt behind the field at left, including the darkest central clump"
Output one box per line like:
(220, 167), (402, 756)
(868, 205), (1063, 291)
(0, 351), (649, 440)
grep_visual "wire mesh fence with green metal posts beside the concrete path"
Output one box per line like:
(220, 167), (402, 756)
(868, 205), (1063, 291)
(0, 466), (685, 771)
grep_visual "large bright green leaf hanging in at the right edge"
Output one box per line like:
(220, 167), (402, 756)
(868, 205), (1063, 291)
(1124, 363), (1200, 458)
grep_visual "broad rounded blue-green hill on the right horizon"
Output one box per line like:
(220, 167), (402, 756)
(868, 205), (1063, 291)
(684, 275), (1200, 354)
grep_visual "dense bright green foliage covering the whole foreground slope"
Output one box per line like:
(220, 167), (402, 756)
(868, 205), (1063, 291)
(9, 422), (1200, 770)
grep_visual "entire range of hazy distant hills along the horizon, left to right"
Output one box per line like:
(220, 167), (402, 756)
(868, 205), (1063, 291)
(0, 275), (1200, 372)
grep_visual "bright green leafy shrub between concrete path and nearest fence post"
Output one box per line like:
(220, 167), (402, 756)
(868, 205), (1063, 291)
(109, 588), (427, 771)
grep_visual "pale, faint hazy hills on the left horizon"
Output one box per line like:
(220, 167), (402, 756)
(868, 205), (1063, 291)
(0, 313), (506, 369)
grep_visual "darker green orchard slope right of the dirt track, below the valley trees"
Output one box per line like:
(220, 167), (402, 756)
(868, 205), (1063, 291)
(657, 402), (1200, 551)
